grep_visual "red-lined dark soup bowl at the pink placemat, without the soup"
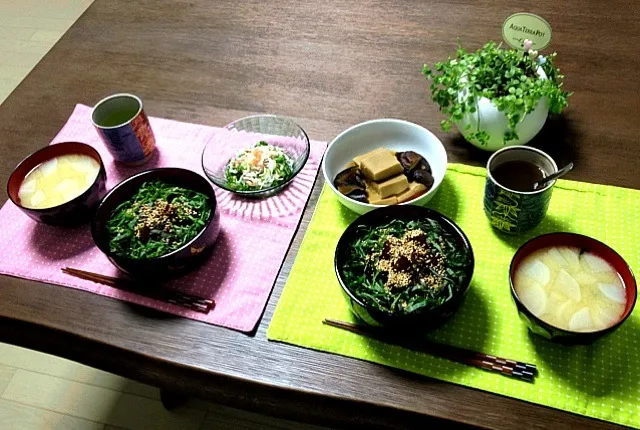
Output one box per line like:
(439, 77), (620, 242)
(7, 142), (107, 226)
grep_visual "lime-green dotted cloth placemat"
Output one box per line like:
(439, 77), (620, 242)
(267, 164), (640, 428)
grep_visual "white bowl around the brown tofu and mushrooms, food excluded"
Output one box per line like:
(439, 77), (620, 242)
(322, 119), (447, 214)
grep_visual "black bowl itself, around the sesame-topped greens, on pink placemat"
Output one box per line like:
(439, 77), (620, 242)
(91, 168), (220, 279)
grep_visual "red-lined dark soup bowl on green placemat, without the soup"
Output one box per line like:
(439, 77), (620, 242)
(509, 233), (638, 344)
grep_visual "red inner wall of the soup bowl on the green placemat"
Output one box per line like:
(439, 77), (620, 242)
(509, 233), (638, 330)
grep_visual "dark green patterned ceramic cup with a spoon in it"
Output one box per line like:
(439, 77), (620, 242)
(484, 146), (558, 234)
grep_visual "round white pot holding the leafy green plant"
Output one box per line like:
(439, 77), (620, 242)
(456, 68), (549, 151)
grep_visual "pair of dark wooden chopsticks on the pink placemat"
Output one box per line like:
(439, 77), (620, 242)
(62, 267), (216, 314)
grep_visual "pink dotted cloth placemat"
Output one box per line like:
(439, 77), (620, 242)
(0, 105), (327, 332)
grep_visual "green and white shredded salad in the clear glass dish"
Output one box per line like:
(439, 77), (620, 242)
(225, 141), (294, 191)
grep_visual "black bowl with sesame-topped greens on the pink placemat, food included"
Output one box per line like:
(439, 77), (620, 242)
(91, 168), (220, 278)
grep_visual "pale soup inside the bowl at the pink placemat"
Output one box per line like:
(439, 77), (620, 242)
(18, 154), (100, 209)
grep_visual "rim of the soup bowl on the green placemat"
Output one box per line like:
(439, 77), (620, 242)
(509, 231), (638, 336)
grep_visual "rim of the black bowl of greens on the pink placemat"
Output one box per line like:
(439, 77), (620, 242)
(91, 167), (219, 263)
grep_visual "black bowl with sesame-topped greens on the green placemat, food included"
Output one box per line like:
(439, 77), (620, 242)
(335, 206), (474, 331)
